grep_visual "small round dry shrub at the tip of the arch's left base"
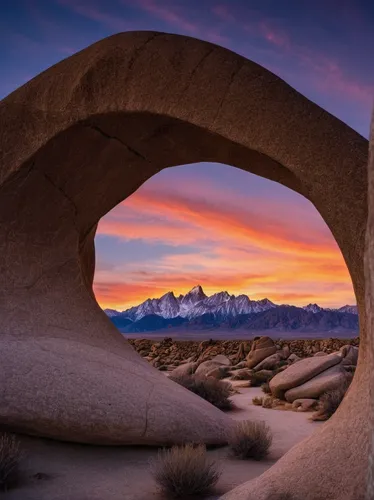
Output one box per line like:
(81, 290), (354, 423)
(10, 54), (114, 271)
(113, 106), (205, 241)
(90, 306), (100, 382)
(229, 420), (273, 460)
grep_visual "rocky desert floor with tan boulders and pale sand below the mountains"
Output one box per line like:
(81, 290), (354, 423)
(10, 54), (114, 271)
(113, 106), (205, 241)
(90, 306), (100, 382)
(2, 337), (359, 500)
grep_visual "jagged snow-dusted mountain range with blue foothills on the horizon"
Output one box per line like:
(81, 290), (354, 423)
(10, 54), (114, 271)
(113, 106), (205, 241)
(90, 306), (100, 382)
(104, 285), (358, 333)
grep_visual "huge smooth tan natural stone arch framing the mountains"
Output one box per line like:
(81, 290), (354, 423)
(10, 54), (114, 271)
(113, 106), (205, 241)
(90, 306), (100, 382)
(0, 32), (369, 500)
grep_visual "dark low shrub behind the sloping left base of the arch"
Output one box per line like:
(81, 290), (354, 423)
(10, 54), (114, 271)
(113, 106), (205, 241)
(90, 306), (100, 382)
(170, 375), (233, 410)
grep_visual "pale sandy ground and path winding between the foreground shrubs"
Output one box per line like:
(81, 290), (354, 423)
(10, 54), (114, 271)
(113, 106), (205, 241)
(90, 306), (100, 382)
(1, 384), (323, 500)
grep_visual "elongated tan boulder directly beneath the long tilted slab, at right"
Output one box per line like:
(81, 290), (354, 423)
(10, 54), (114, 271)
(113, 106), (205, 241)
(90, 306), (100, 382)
(285, 364), (347, 403)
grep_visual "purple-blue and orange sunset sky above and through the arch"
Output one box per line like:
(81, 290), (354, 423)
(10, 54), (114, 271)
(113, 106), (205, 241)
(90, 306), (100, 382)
(0, 0), (374, 309)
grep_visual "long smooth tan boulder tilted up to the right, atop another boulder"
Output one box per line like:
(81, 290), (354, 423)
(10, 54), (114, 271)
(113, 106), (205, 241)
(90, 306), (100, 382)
(270, 353), (342, 399)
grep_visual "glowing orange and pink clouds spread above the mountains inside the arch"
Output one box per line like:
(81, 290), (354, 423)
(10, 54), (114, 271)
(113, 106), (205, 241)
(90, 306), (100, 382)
(95, 180), (353, 308)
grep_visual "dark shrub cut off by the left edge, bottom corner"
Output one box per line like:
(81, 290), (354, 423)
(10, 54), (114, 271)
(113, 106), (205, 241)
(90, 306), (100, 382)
(0, 432), (22, 491)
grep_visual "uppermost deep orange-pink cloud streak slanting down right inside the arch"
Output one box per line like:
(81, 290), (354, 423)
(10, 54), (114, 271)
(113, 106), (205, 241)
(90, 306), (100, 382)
(112, 189), (338, 258)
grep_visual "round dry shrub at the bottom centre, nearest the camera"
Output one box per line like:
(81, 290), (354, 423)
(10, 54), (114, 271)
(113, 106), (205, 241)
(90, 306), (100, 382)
(151, 444), (221, 498)
